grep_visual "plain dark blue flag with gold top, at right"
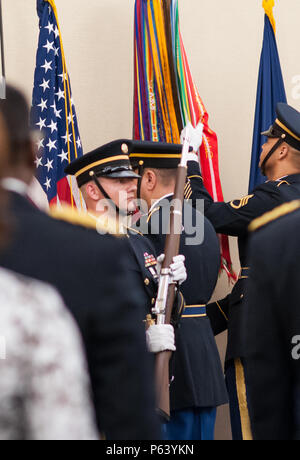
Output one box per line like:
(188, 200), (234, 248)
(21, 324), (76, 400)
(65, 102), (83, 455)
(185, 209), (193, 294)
(249, 0), (287, 193)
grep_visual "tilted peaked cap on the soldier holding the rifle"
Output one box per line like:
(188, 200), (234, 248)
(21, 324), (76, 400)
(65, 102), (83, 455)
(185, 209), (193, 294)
(65, 139), (140, 187)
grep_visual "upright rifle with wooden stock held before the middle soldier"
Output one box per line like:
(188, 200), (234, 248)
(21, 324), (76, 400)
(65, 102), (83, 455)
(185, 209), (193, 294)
(152, 124), (202, 421)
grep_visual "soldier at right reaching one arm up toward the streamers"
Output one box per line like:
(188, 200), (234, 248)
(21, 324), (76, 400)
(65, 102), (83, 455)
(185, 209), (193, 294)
(188, 103), (300, 440)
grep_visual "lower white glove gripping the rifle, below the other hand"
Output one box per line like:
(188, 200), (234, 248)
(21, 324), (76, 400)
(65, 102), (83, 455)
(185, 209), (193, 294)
(146, 324), (176, 353)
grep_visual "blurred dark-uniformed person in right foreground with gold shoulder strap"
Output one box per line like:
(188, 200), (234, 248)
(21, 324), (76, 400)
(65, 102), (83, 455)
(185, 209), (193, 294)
(243, 200), (300, 441)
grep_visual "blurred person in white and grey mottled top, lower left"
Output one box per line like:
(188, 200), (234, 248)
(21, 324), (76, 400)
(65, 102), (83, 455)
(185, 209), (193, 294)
(0, 107), (97, 440)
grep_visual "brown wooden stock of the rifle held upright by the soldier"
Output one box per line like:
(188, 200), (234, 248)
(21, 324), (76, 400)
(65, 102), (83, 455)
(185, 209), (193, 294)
(155, 165), (187, 420)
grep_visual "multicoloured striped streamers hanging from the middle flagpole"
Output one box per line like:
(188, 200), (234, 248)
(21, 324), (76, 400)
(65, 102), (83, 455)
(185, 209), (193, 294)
(134, 0), (234, 277)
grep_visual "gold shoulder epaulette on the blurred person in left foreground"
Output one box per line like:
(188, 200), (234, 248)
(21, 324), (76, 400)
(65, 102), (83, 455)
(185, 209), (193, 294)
(50, 206), (121, 236)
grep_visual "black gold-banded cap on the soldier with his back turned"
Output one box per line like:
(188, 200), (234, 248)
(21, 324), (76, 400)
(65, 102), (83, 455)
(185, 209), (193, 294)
(129, 141), (193, 169)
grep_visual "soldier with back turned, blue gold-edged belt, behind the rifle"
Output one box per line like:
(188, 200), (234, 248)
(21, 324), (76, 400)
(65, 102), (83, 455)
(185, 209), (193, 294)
(130, 141), (228, 440)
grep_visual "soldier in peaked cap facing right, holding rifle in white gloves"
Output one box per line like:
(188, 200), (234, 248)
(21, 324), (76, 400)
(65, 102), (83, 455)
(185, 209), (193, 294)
(65, 139), (187, 353)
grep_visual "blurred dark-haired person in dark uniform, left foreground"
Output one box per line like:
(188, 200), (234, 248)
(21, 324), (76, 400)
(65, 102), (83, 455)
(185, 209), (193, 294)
(0, 87), (160, 440)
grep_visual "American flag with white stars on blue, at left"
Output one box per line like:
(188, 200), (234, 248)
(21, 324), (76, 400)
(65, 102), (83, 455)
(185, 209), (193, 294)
(31, 0), (83, 208)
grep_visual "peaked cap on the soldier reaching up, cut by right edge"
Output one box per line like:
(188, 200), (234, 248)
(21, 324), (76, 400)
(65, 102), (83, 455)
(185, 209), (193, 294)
(262, 102), (300, 150)
